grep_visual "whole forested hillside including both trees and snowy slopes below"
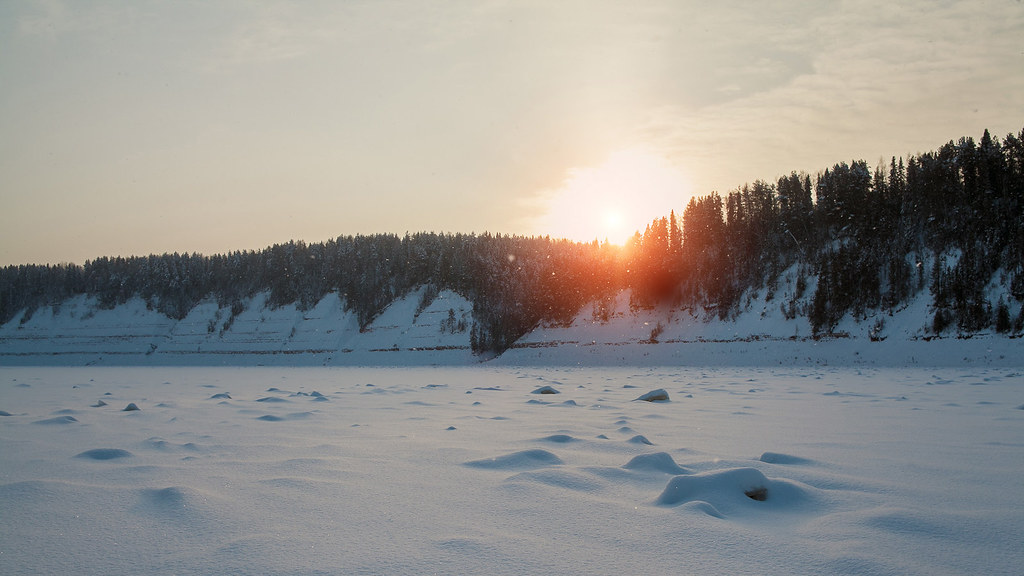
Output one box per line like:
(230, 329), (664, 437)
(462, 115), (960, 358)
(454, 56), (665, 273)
(0, 126), (1024, 364)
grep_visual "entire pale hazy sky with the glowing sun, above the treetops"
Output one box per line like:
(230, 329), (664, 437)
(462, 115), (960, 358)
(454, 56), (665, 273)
(0, 0), (1024, 265)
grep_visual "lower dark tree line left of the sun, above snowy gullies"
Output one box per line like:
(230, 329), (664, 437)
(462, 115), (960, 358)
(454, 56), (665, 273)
(0, 233), (614, 352)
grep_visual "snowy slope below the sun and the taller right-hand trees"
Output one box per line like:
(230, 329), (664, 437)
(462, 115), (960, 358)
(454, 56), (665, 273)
(496, 274), (1024, 366)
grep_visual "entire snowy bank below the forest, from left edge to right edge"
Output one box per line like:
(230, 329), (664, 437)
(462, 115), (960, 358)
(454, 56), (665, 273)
(0, 280), (1024, 366)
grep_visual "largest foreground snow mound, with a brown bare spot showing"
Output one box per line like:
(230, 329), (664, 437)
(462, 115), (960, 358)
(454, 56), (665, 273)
(654, 467), (809, 518)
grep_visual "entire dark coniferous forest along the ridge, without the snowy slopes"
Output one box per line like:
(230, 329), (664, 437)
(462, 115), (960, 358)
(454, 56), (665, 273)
(0, 126), (1024, 352)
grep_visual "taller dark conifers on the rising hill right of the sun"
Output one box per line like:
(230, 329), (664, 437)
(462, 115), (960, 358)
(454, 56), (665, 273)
(632, 125), (1024, 334)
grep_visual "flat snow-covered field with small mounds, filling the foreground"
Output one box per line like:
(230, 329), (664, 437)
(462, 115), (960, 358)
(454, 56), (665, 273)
(0, 366), (1024, 575)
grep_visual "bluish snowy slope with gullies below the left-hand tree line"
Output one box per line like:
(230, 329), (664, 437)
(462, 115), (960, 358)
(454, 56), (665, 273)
(0, 291), (474, 365)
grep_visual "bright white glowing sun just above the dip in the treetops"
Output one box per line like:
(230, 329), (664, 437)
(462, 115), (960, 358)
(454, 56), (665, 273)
(532, 149), (690, 245)
